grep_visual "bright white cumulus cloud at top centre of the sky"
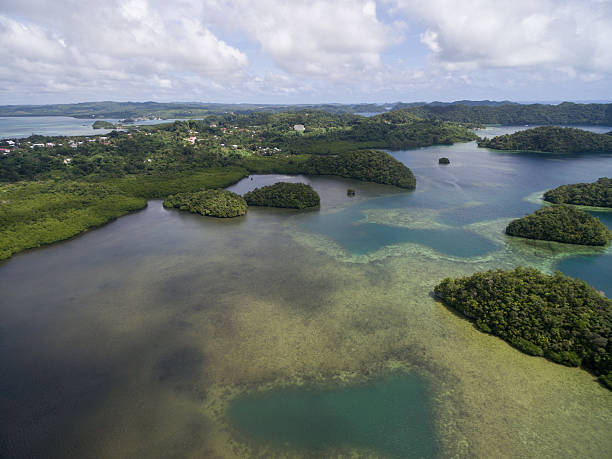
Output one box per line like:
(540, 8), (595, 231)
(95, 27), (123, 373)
(206, 0), (398, 79)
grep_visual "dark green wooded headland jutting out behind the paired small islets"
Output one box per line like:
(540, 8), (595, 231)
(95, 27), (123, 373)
(304, 150), (416, 190)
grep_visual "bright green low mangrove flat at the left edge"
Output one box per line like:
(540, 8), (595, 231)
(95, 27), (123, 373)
(0, 181), (147, 260)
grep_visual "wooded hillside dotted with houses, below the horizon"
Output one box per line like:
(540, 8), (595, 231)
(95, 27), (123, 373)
(0, 111), (476, 182)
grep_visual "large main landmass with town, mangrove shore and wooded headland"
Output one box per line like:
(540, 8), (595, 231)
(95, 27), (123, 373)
(0, 104), (476, 259)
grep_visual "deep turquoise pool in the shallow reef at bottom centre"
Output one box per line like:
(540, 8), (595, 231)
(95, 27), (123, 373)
(229, 375), (436, 458)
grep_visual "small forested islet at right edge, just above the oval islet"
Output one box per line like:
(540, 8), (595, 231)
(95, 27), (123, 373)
(544, 177), (612, 207)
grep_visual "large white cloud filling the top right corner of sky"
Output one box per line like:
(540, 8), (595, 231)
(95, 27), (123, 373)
(392, 0), (612, 77)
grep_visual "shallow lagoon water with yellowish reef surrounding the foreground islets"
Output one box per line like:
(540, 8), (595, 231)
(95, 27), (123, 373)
(0, 126), (612, 457)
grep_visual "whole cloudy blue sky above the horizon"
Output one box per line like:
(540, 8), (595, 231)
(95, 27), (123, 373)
(0, 0), (612, 105)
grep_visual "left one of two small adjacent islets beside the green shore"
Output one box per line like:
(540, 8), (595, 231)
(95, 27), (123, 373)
(164, 189), (247, 218)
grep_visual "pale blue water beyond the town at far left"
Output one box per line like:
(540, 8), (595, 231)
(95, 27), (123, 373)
(0, 116), (191, 139)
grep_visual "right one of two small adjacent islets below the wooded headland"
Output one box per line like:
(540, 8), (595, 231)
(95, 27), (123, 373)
(244, 182), (321, 209)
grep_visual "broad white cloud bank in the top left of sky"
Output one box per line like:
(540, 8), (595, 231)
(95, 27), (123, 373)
(0, 0), (248, 101)
